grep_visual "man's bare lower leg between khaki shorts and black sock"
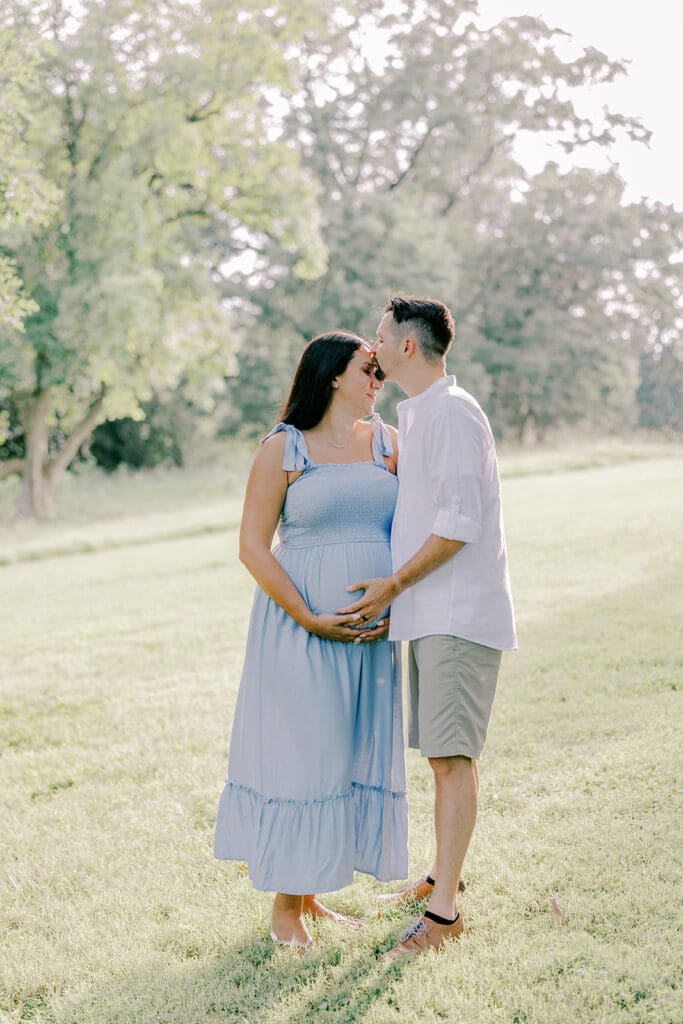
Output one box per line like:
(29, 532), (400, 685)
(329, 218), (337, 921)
(428, 757), (478, 920)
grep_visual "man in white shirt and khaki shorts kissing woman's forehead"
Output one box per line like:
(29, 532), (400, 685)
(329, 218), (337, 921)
(342, 296), (516, 958)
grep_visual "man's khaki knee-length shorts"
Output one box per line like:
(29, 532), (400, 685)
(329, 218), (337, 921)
(408, 634), (502, 758)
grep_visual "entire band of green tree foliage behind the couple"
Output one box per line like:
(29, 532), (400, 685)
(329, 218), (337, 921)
(0, 0), (683, 503)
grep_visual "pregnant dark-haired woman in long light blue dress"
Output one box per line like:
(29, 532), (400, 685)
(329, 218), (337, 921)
(215, 333), (408, 946)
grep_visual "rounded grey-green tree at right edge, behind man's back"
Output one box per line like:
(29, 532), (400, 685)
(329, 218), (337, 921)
(460, 165), (683, 440)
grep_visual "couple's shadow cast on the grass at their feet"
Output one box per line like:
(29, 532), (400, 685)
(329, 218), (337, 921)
(56, 922), (409, 1024)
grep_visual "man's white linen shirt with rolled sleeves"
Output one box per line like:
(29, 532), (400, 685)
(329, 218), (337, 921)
(389, 376), (517, 650)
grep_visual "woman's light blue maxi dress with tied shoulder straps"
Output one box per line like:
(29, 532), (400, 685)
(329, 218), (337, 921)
(215, 415), (408, 894)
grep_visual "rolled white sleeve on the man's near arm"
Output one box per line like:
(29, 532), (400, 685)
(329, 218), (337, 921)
(429, 409), (485, 544)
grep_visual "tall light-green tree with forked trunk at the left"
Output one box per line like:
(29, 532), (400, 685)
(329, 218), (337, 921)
(0, 0), (325, 515)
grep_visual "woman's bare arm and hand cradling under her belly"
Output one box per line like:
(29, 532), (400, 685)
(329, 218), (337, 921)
(240, 433), (368, 640)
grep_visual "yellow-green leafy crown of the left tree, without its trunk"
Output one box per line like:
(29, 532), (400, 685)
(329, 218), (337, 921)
(2, 2), (327, 409)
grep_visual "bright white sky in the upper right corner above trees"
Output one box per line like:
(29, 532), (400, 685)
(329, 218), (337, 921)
(479, 0), (683, 210)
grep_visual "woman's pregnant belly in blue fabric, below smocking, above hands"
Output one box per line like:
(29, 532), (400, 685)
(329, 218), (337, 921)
(274, 544), (392, 614)
